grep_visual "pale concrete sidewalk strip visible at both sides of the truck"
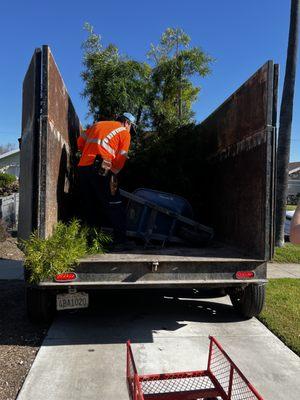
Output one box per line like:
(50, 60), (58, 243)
(0, 259), (300, 280)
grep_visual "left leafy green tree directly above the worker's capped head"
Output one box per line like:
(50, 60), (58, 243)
(81, 23), (151, 128)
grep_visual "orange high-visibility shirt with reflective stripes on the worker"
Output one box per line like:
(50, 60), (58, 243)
(77, 121), (130, 174)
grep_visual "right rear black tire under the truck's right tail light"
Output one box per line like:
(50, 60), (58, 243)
(230, 284), (266, 319)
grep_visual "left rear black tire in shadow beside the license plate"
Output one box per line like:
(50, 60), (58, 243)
(26, 287), (55, 324)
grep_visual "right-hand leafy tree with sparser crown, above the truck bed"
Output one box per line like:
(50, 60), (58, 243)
(148, 28), (213, 131)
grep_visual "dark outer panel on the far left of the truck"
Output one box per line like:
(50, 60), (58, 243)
(18, 49), (41, 239)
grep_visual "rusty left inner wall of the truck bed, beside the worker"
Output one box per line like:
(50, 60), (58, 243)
(38, 46), (80, 237)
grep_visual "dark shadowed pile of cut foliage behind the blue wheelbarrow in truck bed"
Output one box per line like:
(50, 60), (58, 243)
(122, 124), (208, 222)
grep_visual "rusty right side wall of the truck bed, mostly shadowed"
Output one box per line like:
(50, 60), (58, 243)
(198, 61), (277, 259)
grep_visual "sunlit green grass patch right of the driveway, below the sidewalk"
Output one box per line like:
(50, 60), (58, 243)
(259, 278), (300, 355)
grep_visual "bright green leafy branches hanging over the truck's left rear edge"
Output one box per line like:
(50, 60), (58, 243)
(22, 219), (111, 283)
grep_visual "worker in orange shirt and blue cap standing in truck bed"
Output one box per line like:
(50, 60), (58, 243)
(77, 112), (135, 246)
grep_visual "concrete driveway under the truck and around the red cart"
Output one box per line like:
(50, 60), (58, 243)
(18, 296), (300, 400)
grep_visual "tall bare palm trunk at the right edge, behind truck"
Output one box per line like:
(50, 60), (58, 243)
(275, 0), (299, 246)
